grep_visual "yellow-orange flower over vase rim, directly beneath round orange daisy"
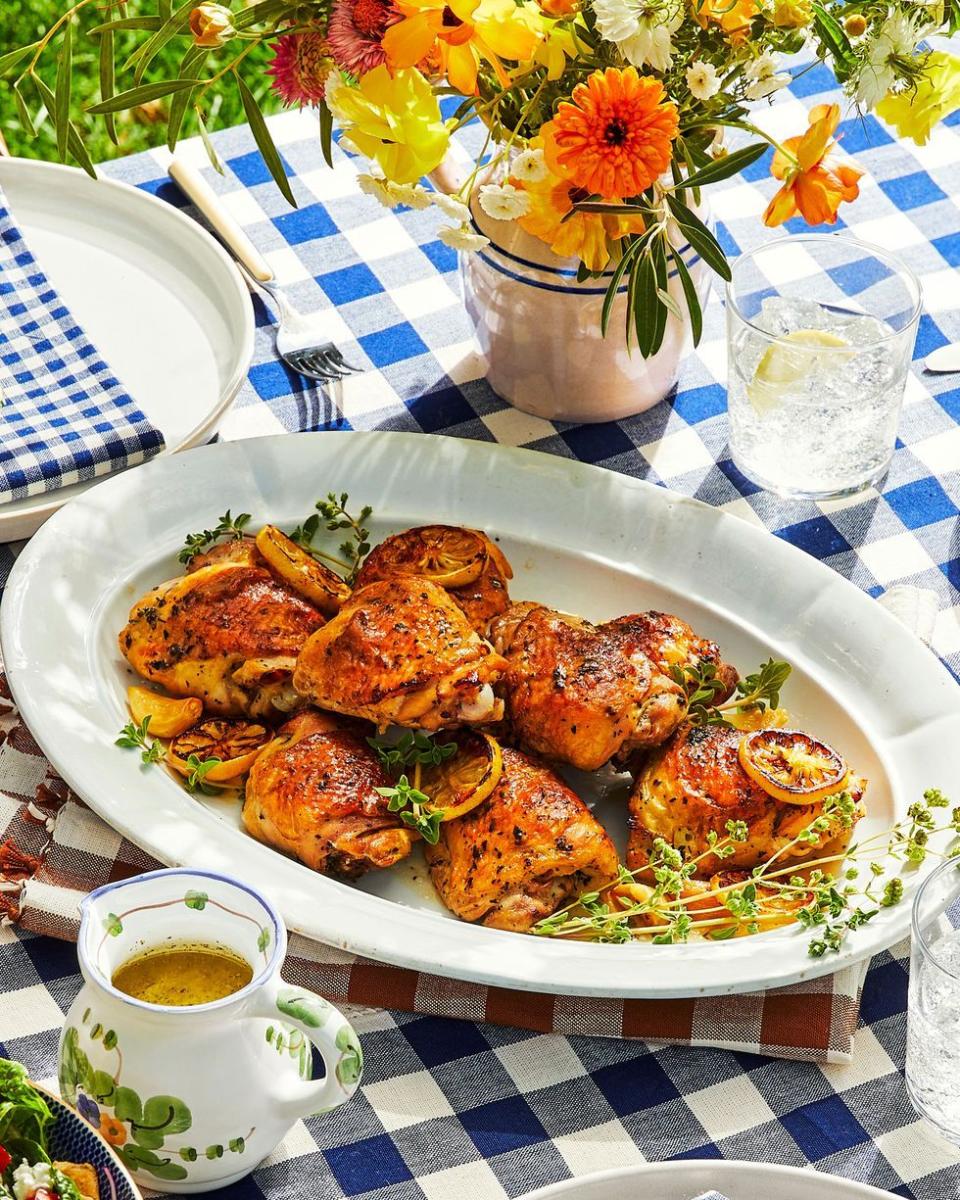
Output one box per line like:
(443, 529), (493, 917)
(510, 138), (643, 271)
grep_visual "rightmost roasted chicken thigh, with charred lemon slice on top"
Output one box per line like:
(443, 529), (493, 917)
(626, 722), (866, 877)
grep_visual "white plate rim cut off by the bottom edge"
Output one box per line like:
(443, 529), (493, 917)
(523, 1159), (890, 1200)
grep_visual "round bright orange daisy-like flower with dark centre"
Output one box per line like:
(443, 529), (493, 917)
(540, 67), (678, 200)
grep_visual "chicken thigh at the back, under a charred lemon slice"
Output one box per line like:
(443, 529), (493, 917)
(356, 526), (514, 634)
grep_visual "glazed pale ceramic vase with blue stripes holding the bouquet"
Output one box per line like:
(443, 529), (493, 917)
(461, 196), (710, 422)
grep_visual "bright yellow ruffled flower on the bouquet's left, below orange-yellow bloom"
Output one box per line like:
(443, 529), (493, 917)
(336, 65), (450, 184)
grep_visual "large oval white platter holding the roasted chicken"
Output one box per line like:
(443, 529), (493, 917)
(0, 433), (960, 996)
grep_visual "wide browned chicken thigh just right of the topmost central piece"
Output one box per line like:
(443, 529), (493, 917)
(491, 602), (737, 770)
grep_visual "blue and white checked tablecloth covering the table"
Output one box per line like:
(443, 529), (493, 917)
(0, 66), (960, 1200)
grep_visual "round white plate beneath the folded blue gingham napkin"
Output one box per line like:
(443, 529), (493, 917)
(0, 158), (253, 542)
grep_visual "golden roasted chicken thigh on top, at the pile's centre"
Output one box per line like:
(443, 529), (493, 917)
(293, 575), (504, 730)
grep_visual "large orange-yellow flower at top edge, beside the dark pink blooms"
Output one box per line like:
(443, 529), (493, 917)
(383, 0), (542, 96)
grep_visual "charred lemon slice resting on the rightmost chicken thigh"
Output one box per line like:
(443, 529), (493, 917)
(738, 730), (847, 804)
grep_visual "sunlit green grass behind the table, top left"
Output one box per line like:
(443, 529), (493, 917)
(0, 0), (281, 162)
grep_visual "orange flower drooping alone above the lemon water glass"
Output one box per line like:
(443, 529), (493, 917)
(763, 104), (863, 226)
